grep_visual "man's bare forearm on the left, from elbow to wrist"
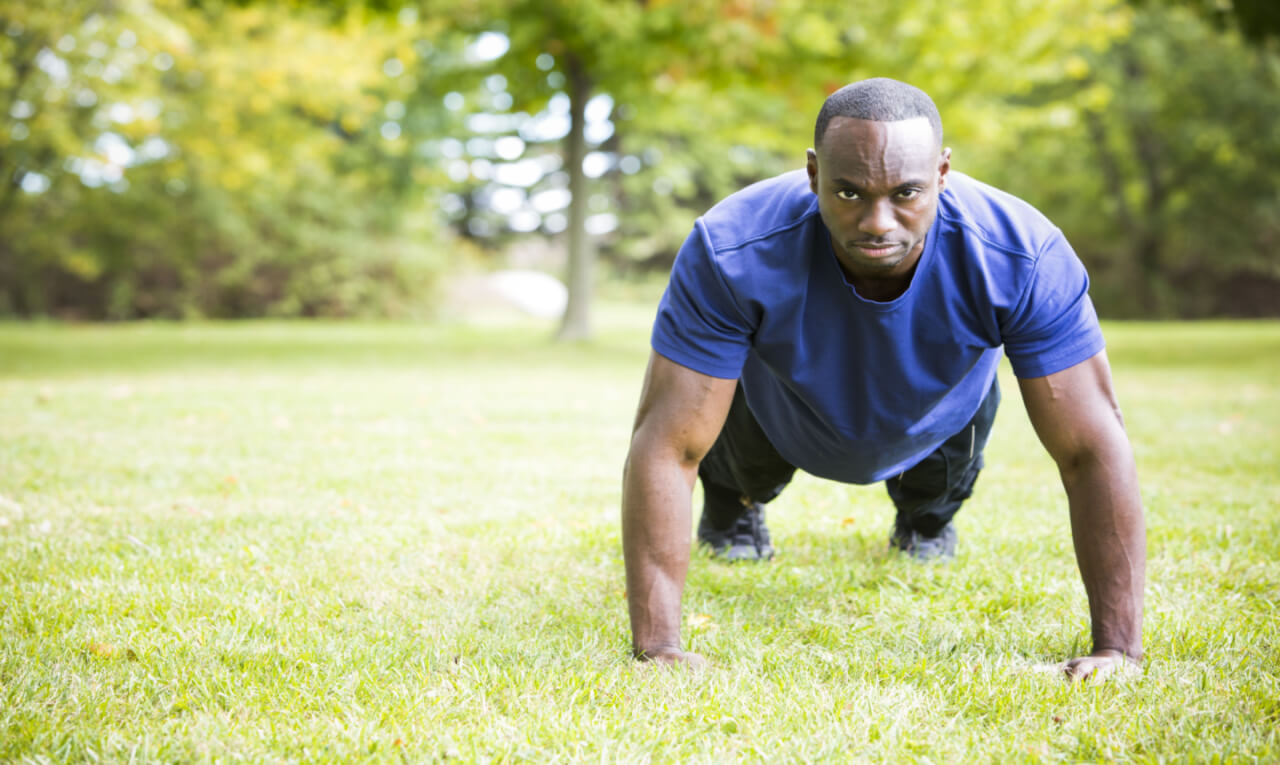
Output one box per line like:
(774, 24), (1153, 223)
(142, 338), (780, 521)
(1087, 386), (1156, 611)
(622, 444), (696, 658)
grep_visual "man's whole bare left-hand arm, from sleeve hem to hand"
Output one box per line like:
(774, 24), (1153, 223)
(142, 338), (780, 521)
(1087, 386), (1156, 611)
(622, 353), (737, 664)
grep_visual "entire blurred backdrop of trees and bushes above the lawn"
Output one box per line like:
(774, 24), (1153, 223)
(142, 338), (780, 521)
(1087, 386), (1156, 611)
(0, 0), (1280, 338)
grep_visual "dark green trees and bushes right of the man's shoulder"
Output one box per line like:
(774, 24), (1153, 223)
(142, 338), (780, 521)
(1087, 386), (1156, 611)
(961, 6), (1280, 317)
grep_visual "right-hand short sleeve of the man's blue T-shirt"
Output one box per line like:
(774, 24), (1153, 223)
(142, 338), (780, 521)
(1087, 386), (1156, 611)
(1001, 232), (1106, 379)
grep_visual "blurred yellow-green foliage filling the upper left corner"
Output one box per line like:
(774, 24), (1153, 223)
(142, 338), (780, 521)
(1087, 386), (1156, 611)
(0, 0), (444, 319)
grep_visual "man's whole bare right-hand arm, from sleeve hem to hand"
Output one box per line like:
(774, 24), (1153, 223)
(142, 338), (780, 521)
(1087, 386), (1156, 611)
(1019, 352), (1147, 679)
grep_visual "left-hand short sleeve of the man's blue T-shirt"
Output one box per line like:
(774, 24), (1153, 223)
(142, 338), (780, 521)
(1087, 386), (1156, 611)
(650, 220), (754, 380)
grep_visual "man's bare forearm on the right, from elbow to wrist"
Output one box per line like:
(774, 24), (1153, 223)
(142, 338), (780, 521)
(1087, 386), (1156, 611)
(1062, 447), (1147, 661)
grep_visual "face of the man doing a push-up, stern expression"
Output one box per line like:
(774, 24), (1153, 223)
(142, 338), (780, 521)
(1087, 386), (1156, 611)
(808, 116), (951, 286)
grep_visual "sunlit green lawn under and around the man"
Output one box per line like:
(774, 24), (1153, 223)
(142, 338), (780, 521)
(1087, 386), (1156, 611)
(0, 303), (1280, 762)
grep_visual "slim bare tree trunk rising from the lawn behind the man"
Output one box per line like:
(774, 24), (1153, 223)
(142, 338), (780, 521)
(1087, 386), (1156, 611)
(556, 54), (595, 340)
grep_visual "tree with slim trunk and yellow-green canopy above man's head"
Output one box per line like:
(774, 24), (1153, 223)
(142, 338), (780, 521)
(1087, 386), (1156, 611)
(424, 0), (1123, 339)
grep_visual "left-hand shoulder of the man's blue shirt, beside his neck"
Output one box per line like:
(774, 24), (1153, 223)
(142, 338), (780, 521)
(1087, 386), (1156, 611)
(700, 169), (818, 253)
